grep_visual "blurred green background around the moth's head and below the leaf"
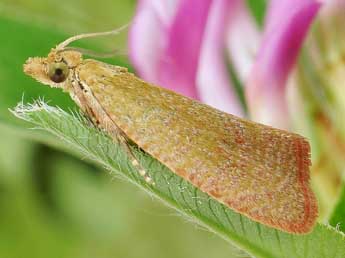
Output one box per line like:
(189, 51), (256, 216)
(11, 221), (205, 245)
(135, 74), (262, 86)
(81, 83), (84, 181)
(0, 0), (246, 258)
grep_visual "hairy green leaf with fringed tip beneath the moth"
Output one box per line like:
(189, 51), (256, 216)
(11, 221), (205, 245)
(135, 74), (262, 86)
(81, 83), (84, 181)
(14, 101), (345, 258)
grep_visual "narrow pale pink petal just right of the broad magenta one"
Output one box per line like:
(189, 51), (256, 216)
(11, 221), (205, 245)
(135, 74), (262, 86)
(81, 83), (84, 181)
(197, 0), (243, 116)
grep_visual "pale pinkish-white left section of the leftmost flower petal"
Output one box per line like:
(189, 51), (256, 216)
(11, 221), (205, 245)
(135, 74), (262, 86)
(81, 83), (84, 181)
(129, 0), (179, 84)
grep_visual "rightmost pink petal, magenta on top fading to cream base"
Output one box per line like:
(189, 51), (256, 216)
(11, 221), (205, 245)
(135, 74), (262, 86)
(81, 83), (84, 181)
(246, 0), (320, 128)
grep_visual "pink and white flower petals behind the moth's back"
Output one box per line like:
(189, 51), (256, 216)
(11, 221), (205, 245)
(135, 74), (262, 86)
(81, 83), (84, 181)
(129, 0), (322, 128)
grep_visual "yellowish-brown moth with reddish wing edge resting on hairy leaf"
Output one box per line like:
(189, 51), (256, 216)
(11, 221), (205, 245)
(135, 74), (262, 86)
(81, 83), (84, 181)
(24, 28), (318, 233)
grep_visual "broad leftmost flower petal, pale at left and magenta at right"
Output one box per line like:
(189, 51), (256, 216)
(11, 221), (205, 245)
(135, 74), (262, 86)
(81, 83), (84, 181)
(129, 0), (211, 98)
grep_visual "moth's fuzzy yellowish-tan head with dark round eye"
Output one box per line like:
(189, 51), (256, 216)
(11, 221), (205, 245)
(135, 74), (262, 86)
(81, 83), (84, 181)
(24, 49), (82, 91)
